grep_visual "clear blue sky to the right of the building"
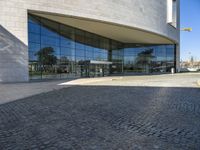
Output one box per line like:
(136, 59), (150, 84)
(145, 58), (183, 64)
(180, 0), (200, 60)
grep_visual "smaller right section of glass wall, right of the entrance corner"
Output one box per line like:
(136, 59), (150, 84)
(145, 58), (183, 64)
(124, 44), (175, 74)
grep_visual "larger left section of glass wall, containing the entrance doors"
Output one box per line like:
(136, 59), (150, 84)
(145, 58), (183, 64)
(28, 15), (123, 79)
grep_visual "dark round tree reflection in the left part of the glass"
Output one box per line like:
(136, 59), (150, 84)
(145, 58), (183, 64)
(35, 47), (57, 71)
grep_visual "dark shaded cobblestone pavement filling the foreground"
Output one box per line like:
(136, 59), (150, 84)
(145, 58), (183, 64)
(0, 86), (200, 150)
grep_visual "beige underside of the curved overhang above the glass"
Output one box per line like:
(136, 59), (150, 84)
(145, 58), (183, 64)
(29, 11), (176, 44)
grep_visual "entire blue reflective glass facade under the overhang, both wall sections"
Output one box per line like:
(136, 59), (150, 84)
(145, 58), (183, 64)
(28, 15), (175, 79)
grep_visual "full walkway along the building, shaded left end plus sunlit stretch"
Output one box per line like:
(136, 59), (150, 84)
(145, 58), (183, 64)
(0, 73), (200, 104)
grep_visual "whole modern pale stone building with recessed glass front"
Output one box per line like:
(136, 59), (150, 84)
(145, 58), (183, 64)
(0, 0), (180, 82)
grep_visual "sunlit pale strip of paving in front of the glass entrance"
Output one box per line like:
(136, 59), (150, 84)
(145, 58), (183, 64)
(61, 73), (200, 88)
